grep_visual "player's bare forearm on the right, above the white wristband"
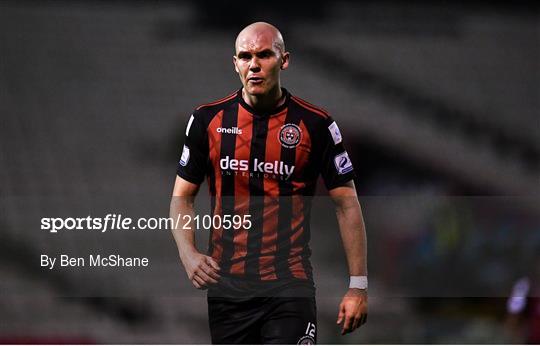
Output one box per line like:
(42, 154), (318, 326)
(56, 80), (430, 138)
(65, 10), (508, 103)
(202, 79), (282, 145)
(336, 196), (367, 276)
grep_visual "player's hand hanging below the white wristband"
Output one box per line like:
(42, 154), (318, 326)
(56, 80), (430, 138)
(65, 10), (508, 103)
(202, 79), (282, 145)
(337, 288), (367, 335)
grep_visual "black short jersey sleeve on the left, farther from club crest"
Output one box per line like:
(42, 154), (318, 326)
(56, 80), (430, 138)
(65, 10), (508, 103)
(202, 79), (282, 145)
(176, 111), (209, 185)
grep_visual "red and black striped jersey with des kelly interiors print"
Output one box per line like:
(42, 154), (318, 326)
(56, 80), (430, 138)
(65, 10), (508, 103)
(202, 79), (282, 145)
(177, 89), (354, 281)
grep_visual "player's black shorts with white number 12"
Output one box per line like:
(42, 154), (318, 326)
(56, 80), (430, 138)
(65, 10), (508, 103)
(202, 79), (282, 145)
(208, 297), (317, 344)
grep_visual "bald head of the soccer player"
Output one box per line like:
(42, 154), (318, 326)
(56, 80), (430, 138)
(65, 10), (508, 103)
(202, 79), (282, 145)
(233, 22), (289, 96)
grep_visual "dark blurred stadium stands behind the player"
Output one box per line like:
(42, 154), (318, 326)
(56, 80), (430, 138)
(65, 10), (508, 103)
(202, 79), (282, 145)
(0, 0), (540, 344)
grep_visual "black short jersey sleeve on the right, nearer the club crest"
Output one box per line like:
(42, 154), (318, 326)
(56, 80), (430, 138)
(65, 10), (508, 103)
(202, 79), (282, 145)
(321, 117), (356, 190)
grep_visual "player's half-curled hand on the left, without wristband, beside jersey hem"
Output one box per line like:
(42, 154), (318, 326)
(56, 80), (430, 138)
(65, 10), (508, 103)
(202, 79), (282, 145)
(180, 251), (220, 290)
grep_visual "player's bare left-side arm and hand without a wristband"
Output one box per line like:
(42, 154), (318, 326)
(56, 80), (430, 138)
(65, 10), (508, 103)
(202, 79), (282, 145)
(170, 176), (219, 289)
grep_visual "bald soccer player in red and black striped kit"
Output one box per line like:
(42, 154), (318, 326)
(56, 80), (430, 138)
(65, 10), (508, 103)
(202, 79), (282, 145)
(171, 22), (367, 344)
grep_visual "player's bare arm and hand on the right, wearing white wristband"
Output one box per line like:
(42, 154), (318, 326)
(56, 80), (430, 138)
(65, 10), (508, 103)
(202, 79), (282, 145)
(329, 180), (367, 334)
